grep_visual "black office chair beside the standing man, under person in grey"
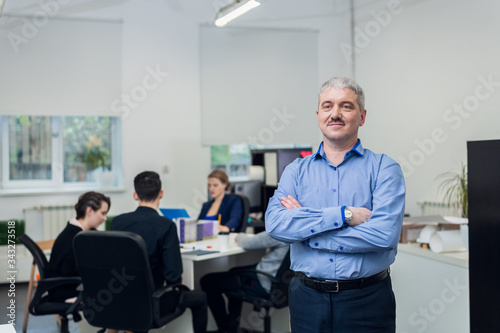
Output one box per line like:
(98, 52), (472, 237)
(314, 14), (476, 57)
(228, 250), (294, 333)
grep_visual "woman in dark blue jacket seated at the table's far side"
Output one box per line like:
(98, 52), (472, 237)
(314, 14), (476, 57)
(198, 170), (243, 232)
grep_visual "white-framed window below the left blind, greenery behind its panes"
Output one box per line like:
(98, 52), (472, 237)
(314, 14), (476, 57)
(0, 116), (121, 189)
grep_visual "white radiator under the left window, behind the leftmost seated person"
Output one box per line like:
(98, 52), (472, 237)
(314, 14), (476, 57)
(24, 205), (76, 241)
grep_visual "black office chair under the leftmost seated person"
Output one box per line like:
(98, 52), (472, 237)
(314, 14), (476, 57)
(18, 235), (81, 333)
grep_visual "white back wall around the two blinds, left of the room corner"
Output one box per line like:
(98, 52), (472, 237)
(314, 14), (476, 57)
(0, 0), (350, 219)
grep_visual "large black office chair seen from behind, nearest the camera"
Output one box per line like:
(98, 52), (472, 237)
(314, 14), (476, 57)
(73, 231), (189, 332)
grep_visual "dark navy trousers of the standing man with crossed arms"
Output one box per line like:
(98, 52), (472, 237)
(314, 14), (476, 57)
(289, 276), (396, 333)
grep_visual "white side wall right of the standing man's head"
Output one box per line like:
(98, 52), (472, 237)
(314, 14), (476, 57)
(356, 0), (500, 215)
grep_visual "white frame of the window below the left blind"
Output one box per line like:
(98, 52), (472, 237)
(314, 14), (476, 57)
(0, 115), (123, 194)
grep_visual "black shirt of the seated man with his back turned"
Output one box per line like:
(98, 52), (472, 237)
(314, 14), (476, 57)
(111, 206), (182, 289)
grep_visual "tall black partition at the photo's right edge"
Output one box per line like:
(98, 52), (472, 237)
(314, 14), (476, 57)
(467, 140), (500, 333)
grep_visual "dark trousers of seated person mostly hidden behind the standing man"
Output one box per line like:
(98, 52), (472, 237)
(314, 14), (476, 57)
(200, 265), (269, 332)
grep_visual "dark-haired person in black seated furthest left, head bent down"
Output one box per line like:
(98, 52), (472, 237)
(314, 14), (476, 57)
(47, 192), (111, 301)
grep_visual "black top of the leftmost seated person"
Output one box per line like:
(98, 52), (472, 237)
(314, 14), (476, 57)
(47, 222), (82, 300)
